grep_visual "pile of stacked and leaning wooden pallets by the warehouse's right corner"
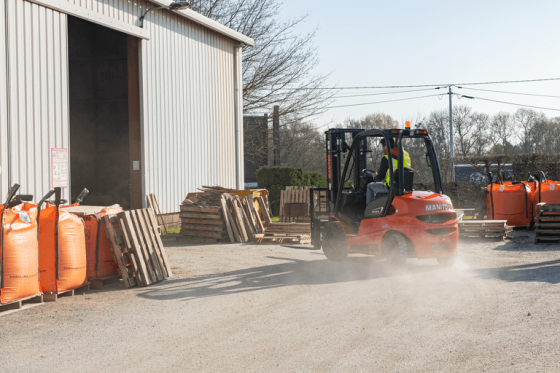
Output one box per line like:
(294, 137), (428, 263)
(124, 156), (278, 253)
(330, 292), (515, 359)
(181, 186), (271, 243)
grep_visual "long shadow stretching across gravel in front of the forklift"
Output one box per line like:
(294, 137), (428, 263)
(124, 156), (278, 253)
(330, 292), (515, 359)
(139, 256), (441, 300)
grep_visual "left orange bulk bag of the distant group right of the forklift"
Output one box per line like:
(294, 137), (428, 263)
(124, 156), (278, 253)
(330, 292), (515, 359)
(486, 181), (536, 226)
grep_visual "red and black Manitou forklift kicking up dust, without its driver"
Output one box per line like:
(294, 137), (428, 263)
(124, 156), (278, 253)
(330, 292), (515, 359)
(310, 123), (459, 266)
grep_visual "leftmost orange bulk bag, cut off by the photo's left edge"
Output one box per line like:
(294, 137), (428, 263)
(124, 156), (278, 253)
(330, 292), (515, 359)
(0, 203), (41, 303)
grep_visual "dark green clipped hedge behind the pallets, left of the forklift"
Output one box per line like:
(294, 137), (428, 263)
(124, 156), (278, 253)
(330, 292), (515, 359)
(257, 166), (327, 216)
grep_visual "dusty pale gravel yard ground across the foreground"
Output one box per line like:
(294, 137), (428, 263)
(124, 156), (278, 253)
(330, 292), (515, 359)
(0, 232), (560, 373)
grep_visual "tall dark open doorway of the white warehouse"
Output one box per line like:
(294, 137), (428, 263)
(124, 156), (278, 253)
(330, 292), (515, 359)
(68, 16), (142, 209)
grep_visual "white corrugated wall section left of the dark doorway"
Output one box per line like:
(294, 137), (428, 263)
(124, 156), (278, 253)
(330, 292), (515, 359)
(2, 0), (69, 200)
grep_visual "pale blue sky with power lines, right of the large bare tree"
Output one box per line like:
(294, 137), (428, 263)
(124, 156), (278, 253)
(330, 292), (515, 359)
(280, 0), (560, 125)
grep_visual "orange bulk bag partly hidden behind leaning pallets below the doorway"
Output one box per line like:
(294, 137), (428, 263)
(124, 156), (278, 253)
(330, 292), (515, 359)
(65, 205), (122, 278)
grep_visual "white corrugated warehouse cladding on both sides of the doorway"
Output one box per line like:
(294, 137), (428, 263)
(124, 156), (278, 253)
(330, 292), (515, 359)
(0, 0), (243, 209)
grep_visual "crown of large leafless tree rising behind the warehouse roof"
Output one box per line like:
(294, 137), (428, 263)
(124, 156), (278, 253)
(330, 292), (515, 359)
(192, 0), (336, 126)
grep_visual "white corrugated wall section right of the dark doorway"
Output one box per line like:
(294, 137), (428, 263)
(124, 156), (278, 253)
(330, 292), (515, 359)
(140, 11), (236, 212)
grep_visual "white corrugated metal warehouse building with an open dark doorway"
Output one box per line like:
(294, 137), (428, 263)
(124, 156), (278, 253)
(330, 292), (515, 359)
(0, 0), (253, 213)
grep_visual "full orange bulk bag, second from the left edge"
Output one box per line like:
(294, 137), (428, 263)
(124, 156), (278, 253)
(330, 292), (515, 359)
(39, 204), (87, 293)
